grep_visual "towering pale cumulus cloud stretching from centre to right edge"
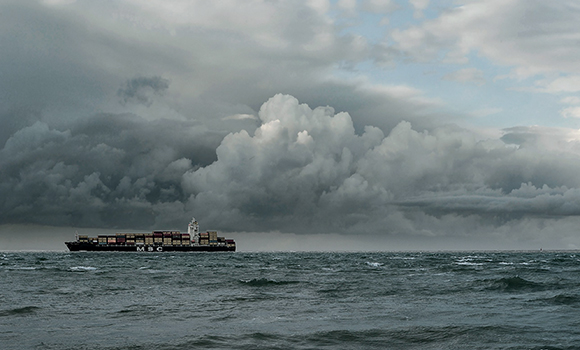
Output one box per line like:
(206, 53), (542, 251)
(183, 95), (580, 234)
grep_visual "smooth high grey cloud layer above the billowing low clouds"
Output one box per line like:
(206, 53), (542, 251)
(0, 1), (447, 138)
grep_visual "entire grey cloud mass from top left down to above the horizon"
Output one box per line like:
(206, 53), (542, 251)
(0, 1), (580, 249)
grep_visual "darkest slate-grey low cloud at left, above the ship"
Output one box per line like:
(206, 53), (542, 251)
(0, 110), (222, 228)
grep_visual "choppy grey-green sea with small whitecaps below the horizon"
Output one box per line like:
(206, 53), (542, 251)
(0, 251), (580, 350)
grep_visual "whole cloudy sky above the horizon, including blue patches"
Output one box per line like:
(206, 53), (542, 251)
(0, 0), (580, 251)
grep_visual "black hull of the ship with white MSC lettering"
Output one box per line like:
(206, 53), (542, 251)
(65, 242), (236, 253)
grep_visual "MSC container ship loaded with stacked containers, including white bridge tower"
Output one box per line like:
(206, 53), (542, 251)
(65, 218), (236, 252)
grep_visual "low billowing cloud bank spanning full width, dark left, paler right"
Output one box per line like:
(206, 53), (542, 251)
(0, 90), (580, 247)
